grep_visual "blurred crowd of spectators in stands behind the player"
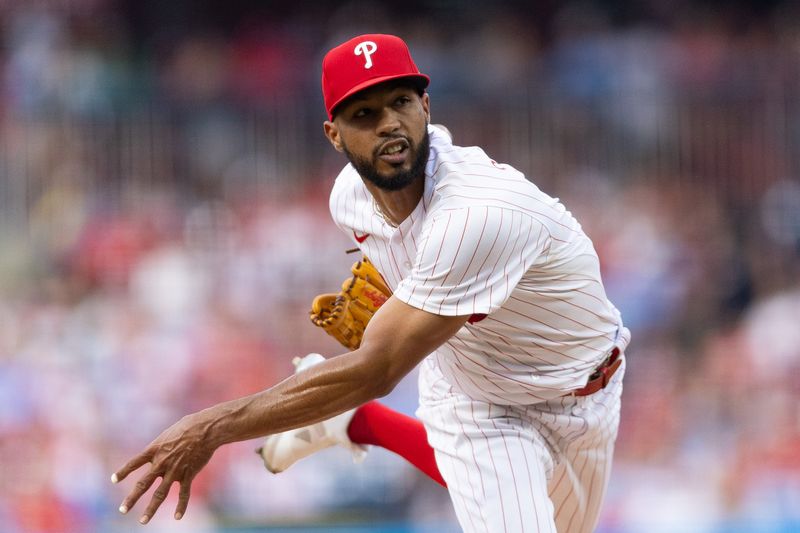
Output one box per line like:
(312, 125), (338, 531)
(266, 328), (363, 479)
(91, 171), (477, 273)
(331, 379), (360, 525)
(0, 0), (800, 533)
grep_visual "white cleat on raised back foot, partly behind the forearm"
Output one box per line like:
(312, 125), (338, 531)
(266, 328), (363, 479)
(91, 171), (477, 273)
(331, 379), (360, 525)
(256, 353), (367, 474)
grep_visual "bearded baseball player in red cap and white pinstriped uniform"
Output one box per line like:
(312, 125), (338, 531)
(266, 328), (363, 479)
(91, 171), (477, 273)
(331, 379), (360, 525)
(112, 34), (629, 533)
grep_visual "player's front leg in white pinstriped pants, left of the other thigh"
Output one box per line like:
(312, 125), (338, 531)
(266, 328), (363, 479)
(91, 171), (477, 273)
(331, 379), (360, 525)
(418, 365), (556, 533)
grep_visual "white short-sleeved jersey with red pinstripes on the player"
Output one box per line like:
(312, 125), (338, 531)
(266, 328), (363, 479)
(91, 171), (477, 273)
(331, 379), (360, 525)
(330, 122), (622, 405)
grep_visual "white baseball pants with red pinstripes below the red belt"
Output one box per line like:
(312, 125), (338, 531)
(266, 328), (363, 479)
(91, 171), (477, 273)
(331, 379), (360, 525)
(417, 356), (625, 533)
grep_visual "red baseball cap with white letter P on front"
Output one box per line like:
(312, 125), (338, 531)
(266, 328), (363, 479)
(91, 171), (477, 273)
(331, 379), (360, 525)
(322, 33), (431, 120)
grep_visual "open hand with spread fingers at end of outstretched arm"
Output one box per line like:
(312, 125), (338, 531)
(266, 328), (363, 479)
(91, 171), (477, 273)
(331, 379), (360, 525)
(111, 413), (219, 524)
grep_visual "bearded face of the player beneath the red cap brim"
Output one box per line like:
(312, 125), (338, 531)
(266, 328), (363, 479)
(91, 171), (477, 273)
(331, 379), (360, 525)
(325, 82), (430, 191)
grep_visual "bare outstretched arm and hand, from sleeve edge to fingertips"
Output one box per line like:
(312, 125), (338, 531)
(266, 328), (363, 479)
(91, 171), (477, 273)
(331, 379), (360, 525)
(112, 298), (468, 524)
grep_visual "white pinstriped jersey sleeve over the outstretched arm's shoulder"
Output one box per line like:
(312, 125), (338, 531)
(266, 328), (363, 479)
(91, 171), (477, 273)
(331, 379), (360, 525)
(394, 206), (550, 316)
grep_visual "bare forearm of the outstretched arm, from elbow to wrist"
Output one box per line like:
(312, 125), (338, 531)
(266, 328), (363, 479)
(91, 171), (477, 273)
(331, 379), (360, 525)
(196, 351), (386, 446)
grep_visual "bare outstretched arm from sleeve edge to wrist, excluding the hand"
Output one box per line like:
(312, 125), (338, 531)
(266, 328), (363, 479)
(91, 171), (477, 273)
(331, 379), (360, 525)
(193, 298), (467, 446)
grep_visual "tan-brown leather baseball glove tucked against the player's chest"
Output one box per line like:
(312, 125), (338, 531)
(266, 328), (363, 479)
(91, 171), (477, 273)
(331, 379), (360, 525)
(309, 257), (392, 350)
